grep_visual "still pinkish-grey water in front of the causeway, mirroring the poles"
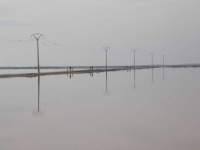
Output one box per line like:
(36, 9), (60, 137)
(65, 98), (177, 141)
(0, 69), (200, 150)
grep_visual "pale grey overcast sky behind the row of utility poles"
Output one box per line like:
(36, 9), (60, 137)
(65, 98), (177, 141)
(0, 0), (200, 66)
